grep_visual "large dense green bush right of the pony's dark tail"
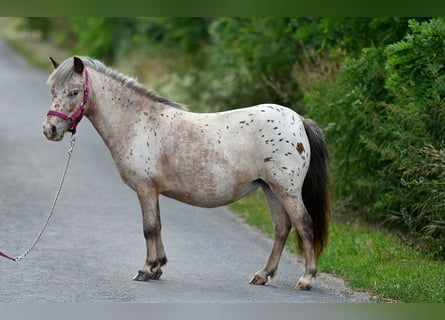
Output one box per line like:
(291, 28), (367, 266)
(307, 18), (445, 258)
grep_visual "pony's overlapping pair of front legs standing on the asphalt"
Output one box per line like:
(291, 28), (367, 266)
(133, 186), (167, 281)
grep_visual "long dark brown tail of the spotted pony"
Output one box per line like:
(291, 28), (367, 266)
(297, 119), (330, 259)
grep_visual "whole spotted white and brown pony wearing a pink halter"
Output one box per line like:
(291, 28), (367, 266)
(43, 57), (329, 289)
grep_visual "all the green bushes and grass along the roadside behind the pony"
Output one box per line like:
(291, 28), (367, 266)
(1, 17), (445, 302)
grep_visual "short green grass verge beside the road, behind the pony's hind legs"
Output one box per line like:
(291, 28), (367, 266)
(231, 191), (445, 303)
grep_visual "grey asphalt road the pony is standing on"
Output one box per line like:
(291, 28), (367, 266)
(0, 39), (368, 302)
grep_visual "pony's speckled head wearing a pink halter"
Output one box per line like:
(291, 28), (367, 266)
(43, 57), (89, 141)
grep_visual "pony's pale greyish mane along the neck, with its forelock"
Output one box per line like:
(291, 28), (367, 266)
(48, 57), (185, 109)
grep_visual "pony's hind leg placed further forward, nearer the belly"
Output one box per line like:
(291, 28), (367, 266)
(250, 184), (291, 285)
